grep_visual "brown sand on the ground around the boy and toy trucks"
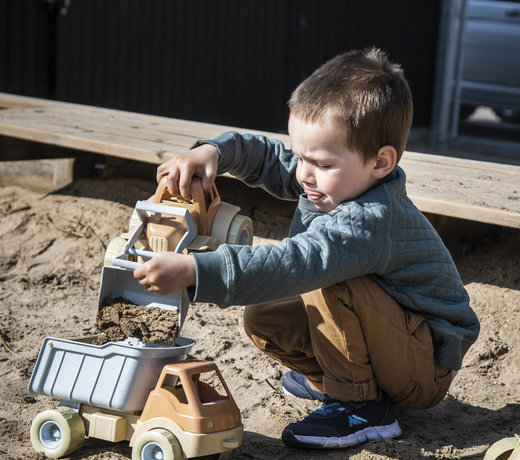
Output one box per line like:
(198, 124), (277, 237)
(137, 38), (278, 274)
(0, 175), (520, 460)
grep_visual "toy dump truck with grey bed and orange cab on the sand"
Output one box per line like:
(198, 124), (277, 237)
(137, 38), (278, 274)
(28, 337), (243, 460)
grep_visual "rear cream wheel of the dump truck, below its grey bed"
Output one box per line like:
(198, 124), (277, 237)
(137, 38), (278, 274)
(31, 407), (85, 458)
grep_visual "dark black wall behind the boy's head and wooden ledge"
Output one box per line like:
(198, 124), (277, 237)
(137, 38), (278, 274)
(0, 0), (441, 131)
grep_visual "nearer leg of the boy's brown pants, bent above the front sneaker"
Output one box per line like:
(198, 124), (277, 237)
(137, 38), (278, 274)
(303, 277), (452, 408)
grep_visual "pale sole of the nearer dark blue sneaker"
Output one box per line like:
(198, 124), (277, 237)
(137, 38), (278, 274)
(282, 420), (402, 449)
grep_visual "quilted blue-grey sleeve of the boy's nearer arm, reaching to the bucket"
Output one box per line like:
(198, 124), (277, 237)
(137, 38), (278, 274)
(192, 207), (387, 307)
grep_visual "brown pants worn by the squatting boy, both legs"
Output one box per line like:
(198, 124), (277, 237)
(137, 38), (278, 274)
(244, 277), (452, 409)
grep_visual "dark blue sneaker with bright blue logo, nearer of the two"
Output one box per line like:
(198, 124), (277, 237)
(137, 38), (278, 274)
(282, 393), (401, 449)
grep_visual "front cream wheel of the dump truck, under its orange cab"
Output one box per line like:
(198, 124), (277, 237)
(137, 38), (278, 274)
(132, 429), (186, 460)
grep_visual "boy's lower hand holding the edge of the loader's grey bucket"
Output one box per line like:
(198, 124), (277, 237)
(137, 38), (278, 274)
(134, 252), (197, 295)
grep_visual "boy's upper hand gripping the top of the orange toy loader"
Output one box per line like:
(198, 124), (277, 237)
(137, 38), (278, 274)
(157, 144), (218, 200)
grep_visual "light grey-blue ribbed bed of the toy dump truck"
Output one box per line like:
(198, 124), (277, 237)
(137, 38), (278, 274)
(27, 337), (195, 412)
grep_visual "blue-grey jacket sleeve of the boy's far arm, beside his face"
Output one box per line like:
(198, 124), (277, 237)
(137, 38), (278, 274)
(194, 131), (302, 200)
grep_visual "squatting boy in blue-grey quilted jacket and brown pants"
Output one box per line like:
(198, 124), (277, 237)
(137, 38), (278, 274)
(134, 49), (479, 448)
